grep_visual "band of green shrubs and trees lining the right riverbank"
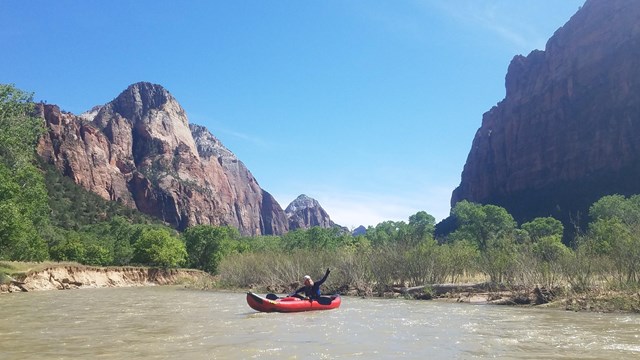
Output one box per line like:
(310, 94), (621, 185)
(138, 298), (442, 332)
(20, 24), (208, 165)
(212, 195), (640, 312)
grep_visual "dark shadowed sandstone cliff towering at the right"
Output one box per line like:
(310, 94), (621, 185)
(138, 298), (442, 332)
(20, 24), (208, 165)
(451, 0), (640, 231)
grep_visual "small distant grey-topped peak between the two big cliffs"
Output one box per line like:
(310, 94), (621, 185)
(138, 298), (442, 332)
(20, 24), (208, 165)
(284, 194), (335, 230)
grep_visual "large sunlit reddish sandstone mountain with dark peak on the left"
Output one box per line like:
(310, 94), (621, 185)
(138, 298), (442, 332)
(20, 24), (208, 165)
(38, 83), (287, 235)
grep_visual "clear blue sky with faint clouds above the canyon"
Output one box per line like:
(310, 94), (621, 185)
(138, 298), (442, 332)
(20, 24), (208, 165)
(0, 0), (584, 228)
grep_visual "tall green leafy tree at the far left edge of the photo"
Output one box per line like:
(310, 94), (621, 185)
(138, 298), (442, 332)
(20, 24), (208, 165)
(0, 84), (49, 261)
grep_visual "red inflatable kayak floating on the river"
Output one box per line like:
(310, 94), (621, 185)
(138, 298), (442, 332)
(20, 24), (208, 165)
(247, 292), (342, 312)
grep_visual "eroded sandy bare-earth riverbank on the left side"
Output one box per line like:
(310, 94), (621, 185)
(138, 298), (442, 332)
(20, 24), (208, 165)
(0, 263), (213, 293)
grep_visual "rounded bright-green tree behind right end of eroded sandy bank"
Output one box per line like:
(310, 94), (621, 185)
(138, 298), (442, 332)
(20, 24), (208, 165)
(133, 229), (187, 267)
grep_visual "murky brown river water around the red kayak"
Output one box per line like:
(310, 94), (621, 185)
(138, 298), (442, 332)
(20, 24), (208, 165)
(0, 287), (640, 360)
